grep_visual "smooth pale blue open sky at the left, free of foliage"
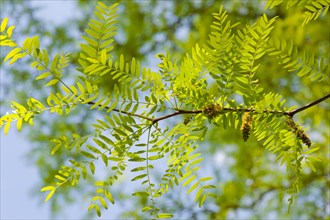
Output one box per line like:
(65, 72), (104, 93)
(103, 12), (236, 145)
(0, 0), (80, 220)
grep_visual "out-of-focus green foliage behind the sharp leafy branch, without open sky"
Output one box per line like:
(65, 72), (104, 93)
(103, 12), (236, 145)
(0, 0), (330, 219)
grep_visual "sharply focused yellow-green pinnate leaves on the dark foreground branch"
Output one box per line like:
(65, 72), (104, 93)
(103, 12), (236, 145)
(0, 1), (329, 218)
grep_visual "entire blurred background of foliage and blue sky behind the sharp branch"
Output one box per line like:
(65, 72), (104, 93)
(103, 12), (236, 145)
(0, 0), (330, 219)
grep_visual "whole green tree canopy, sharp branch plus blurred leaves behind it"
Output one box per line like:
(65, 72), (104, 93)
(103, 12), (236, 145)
(0, 0), (330, 219)
